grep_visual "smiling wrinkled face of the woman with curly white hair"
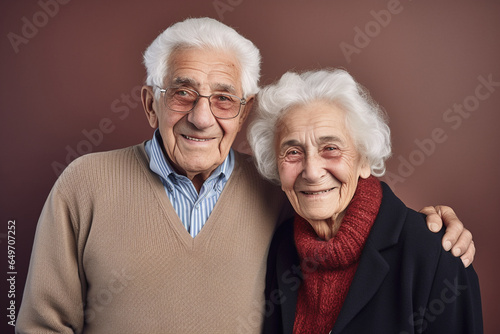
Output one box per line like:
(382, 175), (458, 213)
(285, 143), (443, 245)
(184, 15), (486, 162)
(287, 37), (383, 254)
(276, 101), (370, 222)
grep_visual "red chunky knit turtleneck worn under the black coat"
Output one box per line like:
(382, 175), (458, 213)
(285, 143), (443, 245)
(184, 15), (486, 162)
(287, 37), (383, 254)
(293, 176), (382, 334)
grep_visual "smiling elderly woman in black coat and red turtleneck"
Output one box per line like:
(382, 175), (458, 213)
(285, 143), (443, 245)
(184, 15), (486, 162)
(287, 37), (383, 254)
(249, 70), (482, 334)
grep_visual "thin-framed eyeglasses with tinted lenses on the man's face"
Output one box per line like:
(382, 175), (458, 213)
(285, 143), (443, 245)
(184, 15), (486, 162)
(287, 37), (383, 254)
(158, 87), (247, 119)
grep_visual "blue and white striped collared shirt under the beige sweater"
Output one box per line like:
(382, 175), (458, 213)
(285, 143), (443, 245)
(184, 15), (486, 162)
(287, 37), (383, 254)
(146, 130), (234, 238)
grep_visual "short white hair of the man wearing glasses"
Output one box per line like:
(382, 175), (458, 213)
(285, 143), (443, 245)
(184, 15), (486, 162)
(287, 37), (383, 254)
(144, 17), (260, 98)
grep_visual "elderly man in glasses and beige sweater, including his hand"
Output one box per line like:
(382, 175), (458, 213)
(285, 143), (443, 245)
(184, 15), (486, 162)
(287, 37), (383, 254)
(16, 18), (474, 333)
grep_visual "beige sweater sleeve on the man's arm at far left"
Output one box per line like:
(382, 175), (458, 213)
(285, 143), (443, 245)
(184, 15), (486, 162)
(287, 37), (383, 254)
(16, 168), (85, 333)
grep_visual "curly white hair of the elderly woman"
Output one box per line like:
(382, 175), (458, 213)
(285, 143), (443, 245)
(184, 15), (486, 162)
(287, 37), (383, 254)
(247, 69), (391, 184)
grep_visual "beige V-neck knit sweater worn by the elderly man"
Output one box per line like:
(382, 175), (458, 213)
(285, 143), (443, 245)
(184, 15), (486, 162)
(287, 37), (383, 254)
(16, 144), (290, 334)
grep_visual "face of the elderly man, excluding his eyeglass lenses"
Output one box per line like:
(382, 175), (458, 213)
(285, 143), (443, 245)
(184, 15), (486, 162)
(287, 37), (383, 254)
(148, 49), (251, 187)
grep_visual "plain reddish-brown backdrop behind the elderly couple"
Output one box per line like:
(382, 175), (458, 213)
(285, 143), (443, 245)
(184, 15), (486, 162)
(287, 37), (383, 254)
(0, 0), (500, 333)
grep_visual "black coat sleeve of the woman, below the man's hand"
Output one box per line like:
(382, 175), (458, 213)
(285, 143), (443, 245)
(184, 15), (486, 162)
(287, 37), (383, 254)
(419, 250), (483, 334)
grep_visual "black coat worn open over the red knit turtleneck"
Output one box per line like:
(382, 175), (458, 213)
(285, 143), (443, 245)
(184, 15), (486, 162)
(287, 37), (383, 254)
(263, 183), (483, 334)
